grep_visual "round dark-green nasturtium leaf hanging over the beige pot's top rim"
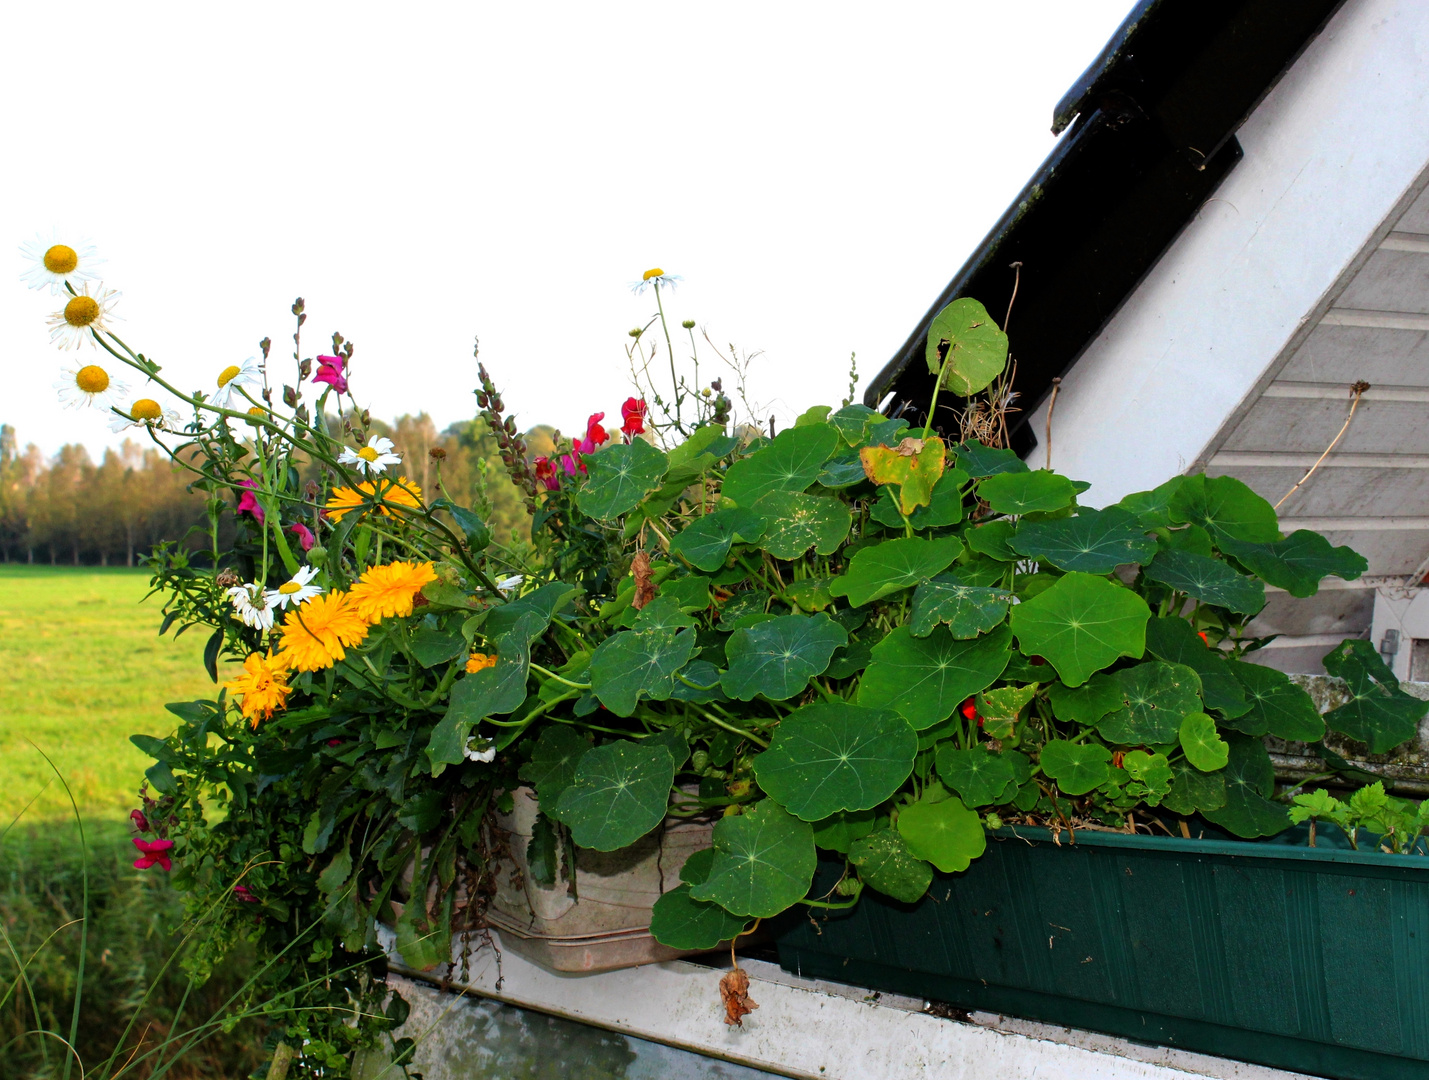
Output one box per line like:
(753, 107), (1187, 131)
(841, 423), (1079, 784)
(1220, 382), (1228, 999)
(546, 740), (674, 851)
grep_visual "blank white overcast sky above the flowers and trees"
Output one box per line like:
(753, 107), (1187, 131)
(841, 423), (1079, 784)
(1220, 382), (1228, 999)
(0, 0), (1130, 453)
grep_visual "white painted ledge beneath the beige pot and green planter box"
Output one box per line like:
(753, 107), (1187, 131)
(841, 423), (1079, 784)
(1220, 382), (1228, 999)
(384, 934), (1300, 1080)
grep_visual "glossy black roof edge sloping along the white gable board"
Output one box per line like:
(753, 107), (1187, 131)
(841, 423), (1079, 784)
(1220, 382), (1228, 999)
(863, 0), (1343, 454)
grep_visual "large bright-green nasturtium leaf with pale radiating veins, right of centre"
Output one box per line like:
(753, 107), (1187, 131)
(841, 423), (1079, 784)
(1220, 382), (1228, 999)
(1012, 573), (1152, 686)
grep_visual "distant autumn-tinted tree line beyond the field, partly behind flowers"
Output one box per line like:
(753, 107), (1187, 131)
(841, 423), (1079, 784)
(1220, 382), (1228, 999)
(0, 413), (547, 566)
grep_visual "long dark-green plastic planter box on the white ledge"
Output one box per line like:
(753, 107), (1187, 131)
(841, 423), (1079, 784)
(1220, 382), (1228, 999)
(779, 827), (1429, 1080)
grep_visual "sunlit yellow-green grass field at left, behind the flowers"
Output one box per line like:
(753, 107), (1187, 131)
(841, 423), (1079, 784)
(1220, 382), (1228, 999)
(0, 564), (225, 830)
